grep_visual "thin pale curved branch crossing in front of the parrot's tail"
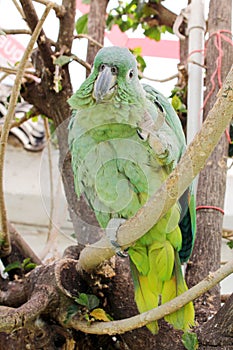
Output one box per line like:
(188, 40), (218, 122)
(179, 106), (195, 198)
(61, 260), (233, 335)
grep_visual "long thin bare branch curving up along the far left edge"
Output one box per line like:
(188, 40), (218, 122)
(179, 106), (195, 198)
(0, 5), (52, 256)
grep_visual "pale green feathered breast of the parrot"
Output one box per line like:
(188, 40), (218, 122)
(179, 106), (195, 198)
(70, 105), (167, 227)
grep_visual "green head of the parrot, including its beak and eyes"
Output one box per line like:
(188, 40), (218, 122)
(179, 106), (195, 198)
(92, 46), (143, 103)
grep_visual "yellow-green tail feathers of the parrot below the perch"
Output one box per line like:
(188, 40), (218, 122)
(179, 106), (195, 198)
(128, 227), (194, 334)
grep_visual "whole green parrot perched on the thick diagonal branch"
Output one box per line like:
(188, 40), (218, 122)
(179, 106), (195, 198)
(68, 46), (196, 334)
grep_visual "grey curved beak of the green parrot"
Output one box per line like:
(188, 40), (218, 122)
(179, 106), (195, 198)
(93, 66), (117, 102)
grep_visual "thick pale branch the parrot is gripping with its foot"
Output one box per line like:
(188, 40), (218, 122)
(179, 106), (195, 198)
(79, 67), (233, 271)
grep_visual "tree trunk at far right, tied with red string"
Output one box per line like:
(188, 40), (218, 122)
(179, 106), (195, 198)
(186, 0), (233, 322)
